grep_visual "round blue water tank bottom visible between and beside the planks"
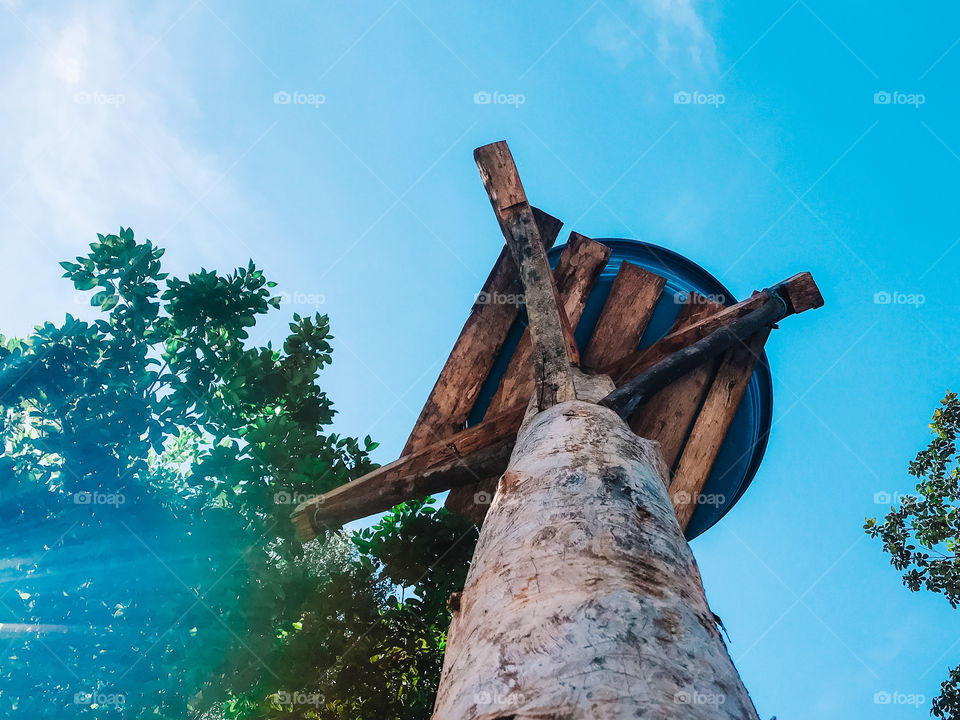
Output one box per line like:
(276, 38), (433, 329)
(469, 238), (773, 540)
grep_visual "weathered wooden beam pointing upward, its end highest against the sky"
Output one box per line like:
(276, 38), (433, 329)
(473, 141), (579, 411)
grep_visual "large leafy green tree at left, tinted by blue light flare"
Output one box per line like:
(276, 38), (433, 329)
(0, 229), (477, 720)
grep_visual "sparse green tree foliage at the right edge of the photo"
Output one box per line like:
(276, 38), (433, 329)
(864, 392), (960, 720)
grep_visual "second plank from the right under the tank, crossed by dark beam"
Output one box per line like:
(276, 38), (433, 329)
(630, 293), (723, 470)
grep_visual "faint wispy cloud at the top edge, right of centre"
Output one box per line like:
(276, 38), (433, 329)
(590, 0), (717, 77)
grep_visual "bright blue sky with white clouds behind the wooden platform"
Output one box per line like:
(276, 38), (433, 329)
(0, 0), (960, 720)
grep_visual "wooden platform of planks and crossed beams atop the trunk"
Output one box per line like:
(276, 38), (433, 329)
(292, 142), (823, 541)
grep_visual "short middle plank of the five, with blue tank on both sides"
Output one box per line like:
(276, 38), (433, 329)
(583, 262), (667, 368)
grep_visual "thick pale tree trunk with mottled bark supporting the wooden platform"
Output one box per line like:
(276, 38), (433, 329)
(433, 400), (757, 720)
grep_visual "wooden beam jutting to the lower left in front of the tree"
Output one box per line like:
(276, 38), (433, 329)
(291, 407), (525, 541)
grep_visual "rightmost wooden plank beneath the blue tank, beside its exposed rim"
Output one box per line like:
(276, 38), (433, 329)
(670, 328), (770, 529)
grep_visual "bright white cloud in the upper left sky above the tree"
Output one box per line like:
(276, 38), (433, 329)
(0, 0), (250, 335)
